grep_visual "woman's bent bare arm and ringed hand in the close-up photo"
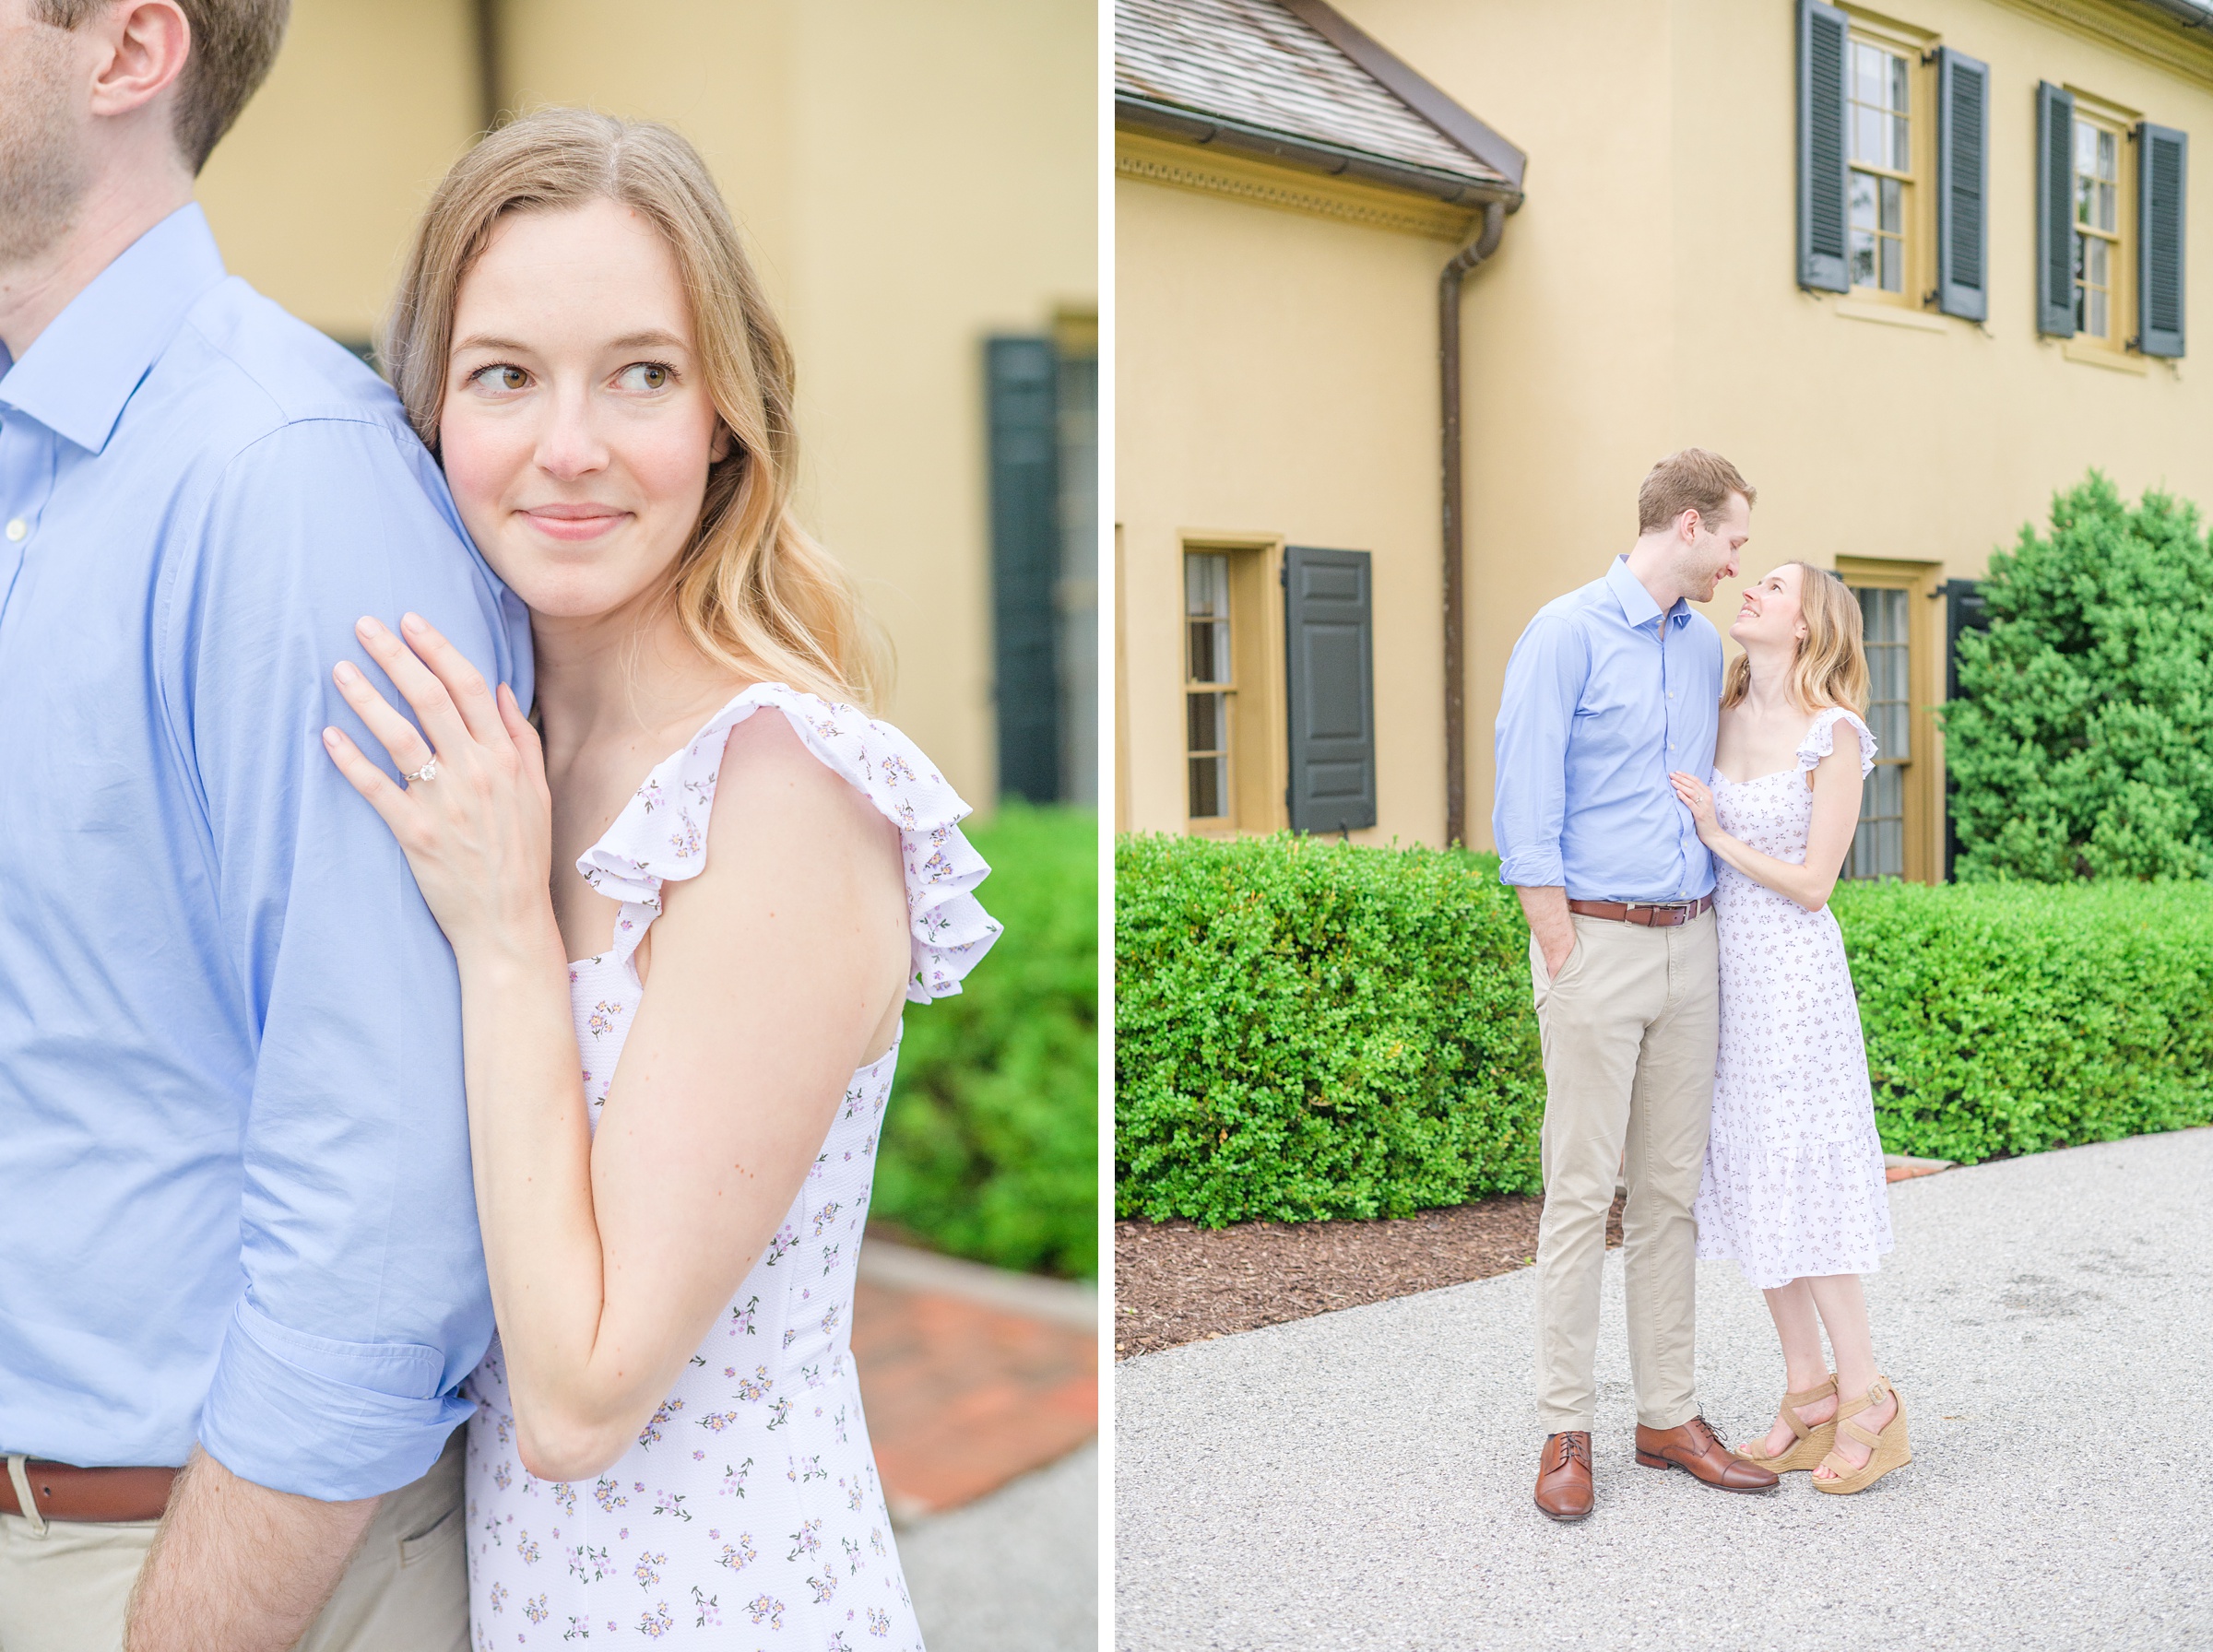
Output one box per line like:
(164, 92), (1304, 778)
(332, 631), (907, 1480)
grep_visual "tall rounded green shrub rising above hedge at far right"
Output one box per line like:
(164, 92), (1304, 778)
(1943, 471), (2213, 882)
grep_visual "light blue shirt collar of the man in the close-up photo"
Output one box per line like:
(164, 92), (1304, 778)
(0, 201), (226, 454)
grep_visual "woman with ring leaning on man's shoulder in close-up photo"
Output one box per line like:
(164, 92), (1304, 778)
(325, 111), (998, 1652)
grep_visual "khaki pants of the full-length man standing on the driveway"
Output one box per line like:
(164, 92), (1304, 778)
(1529, 909), (1720, 1434)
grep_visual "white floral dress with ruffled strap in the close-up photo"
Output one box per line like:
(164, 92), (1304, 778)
(463, 683), (998, 1652)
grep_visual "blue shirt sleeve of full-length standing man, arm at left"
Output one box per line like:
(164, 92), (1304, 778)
(1492, 613), (1589, 889)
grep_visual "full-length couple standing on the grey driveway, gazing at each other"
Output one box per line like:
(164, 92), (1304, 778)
(1492, 449), (1910, 1521)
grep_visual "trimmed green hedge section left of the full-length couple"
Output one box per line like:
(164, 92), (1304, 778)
(1116, 833), (1544, 1227)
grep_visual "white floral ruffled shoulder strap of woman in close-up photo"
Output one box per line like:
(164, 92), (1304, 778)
(575, 683), (1000, 1004)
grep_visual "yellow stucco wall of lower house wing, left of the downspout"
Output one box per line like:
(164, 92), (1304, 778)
(1116, 164), (1451, 843)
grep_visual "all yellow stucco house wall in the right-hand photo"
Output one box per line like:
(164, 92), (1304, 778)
(1118, 0), (2213, 843)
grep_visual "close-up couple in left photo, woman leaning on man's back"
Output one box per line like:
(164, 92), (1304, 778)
(0, 0), (998, 1652)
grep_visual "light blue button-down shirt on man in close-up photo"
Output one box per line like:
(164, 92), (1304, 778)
(0, 206), (529, 1499)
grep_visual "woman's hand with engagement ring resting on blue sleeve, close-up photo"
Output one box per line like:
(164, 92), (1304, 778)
(323, 615), (560, 953)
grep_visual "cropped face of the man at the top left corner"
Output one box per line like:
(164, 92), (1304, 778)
(0, 0), (90, 270)
